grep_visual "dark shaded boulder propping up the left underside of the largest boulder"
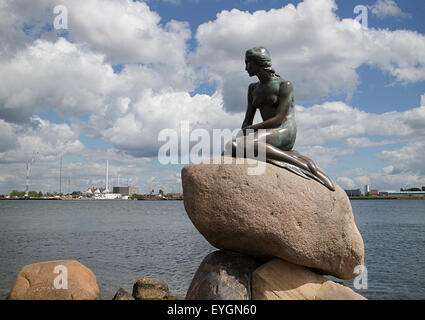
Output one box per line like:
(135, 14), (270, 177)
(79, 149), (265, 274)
(186, 251), (258, 300)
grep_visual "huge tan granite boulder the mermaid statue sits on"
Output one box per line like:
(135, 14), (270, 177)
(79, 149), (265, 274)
(182, 157), (364, 279)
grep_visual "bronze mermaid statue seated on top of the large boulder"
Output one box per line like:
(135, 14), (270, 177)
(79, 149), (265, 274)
(224, 47), (335, 191)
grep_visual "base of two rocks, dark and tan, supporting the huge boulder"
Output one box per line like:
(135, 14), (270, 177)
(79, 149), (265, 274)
(186, 250), (366, 300)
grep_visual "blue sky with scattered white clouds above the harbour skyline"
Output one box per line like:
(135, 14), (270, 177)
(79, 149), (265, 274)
(0, 0), (425, 193)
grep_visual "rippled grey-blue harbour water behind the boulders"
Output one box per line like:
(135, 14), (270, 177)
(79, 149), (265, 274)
(0, 200), (425, 299)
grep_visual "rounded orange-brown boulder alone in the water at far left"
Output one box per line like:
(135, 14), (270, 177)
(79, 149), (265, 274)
(8, 260), (100, 300)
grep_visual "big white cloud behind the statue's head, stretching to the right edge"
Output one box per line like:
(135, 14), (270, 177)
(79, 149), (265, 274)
(192, 0), (425, 110)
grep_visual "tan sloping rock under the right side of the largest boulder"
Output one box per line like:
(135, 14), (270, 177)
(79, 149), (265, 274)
(252, 259), (366, 300)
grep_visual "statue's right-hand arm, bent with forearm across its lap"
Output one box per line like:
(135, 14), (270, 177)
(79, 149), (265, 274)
(247, 82), (293, 130)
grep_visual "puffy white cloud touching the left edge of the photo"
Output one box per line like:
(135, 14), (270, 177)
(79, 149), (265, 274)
(0, 38), (119, 122)
